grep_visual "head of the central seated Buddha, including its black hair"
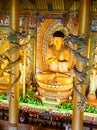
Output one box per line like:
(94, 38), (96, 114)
(53, 31), (64, 50)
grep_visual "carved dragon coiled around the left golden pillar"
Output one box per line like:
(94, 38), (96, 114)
(0, 29), (34, 99)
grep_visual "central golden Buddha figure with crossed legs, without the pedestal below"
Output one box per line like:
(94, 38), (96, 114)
(36, 31), (73, 85)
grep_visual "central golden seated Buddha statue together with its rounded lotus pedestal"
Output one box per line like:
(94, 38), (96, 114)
(35, 31), (74, 104)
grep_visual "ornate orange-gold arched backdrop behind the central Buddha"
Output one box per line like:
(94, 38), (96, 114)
(37, 19), (77, 71)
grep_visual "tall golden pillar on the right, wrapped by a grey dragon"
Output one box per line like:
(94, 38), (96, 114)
(72, 0), (90, 130)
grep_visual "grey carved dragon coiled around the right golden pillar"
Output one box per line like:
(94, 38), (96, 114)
(65, 34), (91, 110)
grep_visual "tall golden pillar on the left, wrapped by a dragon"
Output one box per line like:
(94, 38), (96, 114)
(9, 0), (19, 130)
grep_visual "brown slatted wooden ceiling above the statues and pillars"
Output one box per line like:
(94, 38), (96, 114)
(0, 0), (97, 15)
